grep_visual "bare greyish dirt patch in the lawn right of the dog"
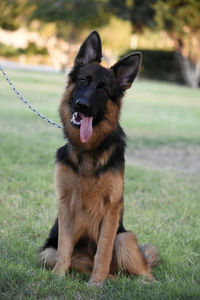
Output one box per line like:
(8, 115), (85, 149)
(126, 146), (200, 177)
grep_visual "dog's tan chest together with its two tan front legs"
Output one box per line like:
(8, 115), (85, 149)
(54, 164), (123, 282)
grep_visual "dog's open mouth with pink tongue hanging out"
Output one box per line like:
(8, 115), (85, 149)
(71, 112), (93, 143)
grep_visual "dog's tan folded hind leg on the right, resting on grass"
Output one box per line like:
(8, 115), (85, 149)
(114, 231), (158, 279)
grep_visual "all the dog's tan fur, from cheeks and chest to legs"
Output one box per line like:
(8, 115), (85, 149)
(39, 64), (159, 285)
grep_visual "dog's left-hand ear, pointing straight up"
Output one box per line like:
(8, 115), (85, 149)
(74, 31), (102, 67)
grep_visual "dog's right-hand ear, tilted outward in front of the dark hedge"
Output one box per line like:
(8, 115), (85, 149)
(111, 52), (142, 90)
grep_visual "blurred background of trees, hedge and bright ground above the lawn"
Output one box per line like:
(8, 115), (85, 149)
(0, 0), (200, 88)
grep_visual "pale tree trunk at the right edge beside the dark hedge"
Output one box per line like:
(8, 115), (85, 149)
(176, 53), (200, 88)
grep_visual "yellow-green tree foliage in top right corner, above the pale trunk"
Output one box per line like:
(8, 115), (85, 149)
(154, 0), (200, 61)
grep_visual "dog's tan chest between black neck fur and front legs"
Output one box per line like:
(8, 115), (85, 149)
(56, 164), (123, 241)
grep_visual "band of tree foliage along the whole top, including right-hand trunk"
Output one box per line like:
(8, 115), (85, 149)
(0, 0), (200, 87)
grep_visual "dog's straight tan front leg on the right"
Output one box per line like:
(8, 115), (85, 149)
(88, 203), (121, 286)
